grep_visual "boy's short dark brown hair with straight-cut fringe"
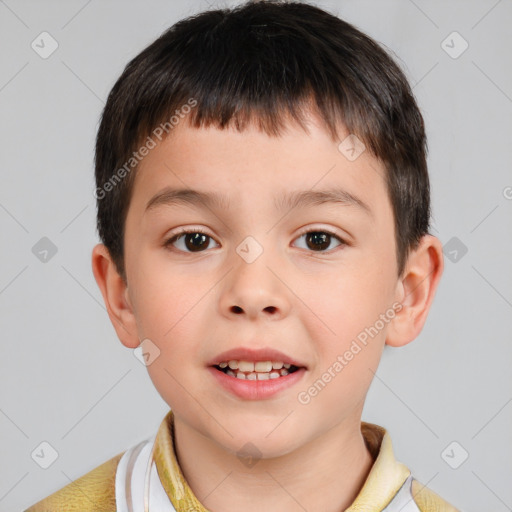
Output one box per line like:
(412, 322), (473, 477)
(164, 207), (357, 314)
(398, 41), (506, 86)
(95, 0), (430, 282)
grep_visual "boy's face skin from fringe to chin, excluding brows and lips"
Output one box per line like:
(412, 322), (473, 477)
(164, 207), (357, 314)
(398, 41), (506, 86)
(118, 115), (402, 457)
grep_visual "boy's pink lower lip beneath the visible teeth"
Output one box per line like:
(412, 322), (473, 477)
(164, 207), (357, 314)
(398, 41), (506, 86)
(208, 366), (306, 400)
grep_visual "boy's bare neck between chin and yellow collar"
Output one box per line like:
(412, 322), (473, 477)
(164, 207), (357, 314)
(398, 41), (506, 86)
(174, 417), (373, 512)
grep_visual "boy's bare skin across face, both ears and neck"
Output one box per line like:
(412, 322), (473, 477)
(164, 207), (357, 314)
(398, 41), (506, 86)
(92, 111), (443, 512)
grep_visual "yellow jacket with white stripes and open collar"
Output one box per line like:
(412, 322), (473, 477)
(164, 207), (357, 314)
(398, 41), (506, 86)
(24, 410), (458, 512)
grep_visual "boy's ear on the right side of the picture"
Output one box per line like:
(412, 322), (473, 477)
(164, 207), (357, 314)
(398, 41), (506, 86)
(386, 235), (444, 347)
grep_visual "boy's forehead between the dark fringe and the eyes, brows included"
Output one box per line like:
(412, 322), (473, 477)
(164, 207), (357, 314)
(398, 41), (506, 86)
(132, 116), (387, 218)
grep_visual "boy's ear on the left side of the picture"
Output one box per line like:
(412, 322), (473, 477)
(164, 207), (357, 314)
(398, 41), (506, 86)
(92, 244), (140, 348)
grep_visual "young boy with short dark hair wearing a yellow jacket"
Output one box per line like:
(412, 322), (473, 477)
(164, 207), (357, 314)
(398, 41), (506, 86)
(28, 1), (456, 512)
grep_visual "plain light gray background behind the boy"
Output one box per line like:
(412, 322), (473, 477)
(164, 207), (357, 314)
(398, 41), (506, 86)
(0, 0), (512, 512)
